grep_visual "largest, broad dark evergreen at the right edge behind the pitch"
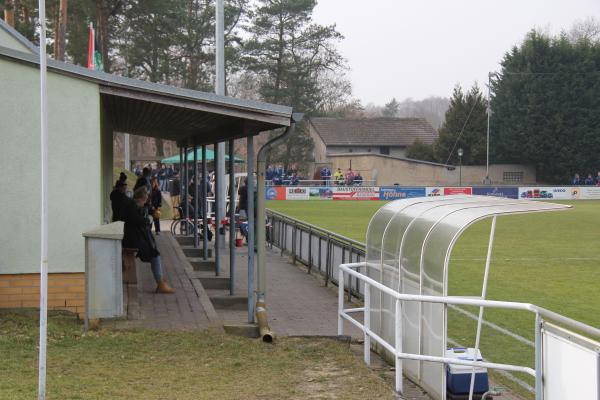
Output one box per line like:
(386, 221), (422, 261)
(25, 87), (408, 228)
(491, 31), (600, 183)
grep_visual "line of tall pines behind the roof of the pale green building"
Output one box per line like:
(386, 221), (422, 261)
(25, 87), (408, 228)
(0, 0), (356, 164)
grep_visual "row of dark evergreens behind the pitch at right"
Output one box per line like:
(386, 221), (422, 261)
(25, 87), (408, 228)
(406, 18), (600, 183)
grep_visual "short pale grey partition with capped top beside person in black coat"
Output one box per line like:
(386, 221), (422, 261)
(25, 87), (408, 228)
(83, 222), (124, 329)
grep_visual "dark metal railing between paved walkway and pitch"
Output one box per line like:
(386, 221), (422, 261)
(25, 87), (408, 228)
(267, 210), (365, 299)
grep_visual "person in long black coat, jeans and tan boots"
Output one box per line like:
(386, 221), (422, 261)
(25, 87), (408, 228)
(123, 187), (175, 293)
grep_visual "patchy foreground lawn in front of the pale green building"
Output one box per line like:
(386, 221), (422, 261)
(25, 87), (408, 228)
(0, 310), (393, 400)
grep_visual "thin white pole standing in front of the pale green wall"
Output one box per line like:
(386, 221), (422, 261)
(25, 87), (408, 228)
(38, 0), (48, 400)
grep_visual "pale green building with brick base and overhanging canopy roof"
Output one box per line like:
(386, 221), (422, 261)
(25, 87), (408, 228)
(0, 20), (292, 312)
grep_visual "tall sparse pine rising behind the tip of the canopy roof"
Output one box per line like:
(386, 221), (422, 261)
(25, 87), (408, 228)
(244, 0), (345, 170)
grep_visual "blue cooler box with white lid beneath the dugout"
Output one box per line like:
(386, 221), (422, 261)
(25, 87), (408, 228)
(446, 348), (489, 394)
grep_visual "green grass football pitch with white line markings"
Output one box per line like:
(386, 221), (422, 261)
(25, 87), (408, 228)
(267, 200), (600, 396)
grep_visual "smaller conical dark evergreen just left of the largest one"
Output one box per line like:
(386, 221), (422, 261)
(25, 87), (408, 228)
(433, 84), (487, 165)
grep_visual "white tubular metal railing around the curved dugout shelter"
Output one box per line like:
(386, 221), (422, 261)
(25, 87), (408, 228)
(338, 262), (600, 400)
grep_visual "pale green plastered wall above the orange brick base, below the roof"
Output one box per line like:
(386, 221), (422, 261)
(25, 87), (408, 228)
(0, 59), (103, 274)
